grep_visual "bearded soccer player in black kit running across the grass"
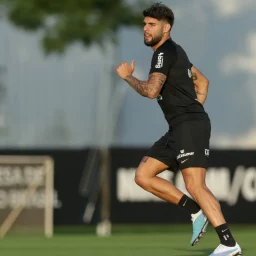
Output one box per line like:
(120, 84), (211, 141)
(116, 3), (242, 256)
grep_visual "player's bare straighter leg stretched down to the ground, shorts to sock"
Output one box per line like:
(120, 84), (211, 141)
(182, 167), (226, 227)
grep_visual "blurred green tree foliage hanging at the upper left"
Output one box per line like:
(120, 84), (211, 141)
(0, 0), (143, 54)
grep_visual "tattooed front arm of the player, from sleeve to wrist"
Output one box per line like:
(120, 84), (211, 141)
(124, 73), (166, 98)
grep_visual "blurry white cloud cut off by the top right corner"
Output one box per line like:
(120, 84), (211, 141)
(211, 0), (256, 18)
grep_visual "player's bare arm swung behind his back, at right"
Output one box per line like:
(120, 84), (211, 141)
(191, 66), (209, 104)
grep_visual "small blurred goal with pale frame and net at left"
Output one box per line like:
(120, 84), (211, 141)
(0, 156), (54, 238)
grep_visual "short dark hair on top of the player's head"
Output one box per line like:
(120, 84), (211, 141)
(143, 3), (174, 27)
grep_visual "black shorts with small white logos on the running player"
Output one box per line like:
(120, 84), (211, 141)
(146, 119), (211, 172)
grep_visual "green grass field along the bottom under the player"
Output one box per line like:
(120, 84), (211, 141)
(0, 225), (256, 256)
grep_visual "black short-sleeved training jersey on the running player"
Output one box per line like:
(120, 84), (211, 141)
(150, 39), (208, 125)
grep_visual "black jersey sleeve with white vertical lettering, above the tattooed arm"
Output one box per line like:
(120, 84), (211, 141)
(149, 49), (176, 76)
